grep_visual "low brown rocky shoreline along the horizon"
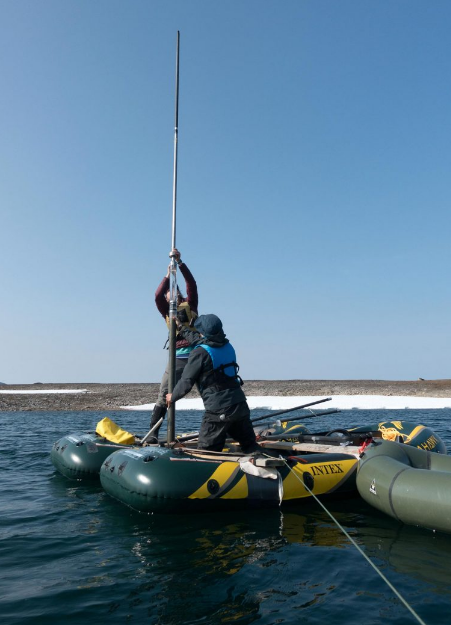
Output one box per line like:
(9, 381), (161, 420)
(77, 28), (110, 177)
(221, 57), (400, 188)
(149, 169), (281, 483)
(0, 379), (451, 412)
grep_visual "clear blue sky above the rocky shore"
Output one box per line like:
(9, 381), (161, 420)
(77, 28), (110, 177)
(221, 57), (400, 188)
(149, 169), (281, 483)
(0, 0), (451, 384)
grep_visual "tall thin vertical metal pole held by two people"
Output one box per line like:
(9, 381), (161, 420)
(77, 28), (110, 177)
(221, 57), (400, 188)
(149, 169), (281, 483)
(168, 31), (180, 444)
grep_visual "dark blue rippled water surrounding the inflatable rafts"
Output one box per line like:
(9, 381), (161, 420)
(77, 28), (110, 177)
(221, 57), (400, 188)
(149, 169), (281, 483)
(0, 410), (451, 625)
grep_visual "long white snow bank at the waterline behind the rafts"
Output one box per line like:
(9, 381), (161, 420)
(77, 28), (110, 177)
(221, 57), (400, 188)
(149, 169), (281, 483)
(121, 395), (451, 410)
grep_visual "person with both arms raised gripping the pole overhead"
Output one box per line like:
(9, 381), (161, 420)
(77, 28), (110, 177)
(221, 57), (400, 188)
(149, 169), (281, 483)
(148, 248), (199, 443)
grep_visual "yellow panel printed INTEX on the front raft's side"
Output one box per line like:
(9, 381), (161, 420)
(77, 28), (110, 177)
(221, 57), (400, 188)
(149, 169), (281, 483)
(283, 458), (357, 501)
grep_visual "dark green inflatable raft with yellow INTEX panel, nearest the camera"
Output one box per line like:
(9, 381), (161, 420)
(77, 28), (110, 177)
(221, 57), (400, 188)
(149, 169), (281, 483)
(100, 447), (357, 513)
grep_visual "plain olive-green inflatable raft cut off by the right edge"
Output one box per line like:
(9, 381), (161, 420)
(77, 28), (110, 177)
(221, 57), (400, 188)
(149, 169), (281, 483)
(357, 441), (451, 533)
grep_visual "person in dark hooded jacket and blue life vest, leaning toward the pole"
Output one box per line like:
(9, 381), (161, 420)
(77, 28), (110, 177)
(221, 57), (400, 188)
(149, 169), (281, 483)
(166, 315), (260, 453)
